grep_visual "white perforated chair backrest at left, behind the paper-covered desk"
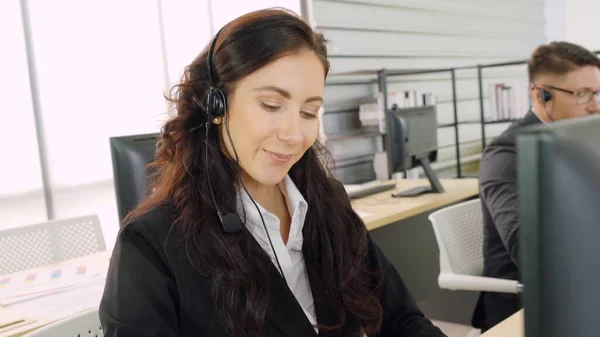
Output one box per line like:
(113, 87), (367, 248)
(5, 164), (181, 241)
(0, 215), (106, 275)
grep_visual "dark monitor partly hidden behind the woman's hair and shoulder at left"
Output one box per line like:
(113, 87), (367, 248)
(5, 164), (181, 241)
(110, 134), (158, 222)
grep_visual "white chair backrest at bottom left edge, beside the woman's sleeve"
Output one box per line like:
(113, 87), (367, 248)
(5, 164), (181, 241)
(23, 308), (104, 337)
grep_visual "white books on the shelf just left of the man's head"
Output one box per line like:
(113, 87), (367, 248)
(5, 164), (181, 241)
(486, 81), (531, 121)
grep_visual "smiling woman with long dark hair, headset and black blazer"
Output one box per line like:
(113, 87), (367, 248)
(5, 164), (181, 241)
(100, 9), (444, 337)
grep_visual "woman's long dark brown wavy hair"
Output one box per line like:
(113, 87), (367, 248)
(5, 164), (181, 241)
(124, 9), (382, 337)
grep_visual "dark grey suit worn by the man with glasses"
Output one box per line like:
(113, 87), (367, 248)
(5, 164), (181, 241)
(472, 111), (541, 331)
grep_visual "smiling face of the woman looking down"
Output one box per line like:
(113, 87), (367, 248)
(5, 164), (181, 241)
(220, 52), (325, 185)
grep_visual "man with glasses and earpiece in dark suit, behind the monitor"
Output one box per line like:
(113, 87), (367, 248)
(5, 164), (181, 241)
(472, 42), (600, 331)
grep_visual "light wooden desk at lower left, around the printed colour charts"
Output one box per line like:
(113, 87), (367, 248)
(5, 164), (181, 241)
(0, 251), (110, 337)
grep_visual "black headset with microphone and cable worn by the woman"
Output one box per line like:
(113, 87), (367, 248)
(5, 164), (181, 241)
(200, 28), (287, 276)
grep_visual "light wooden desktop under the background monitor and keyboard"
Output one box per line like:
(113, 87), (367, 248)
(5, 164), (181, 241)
(352, 178), (479, 230)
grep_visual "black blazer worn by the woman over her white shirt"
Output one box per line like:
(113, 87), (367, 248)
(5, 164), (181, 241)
(100, 201), (445, 337)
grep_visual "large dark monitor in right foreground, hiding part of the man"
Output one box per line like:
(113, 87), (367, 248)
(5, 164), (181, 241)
(517, 116), (600, 337)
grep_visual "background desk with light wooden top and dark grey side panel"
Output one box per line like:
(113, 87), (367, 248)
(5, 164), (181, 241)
(352, 178), (478, 308)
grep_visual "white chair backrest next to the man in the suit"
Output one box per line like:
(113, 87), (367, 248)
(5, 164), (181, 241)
(429, 199), (483, 276)
